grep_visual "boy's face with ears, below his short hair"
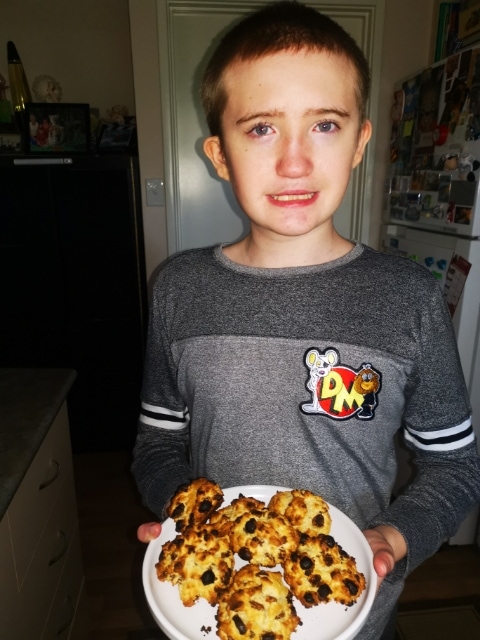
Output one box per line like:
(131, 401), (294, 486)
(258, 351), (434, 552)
(204, 51), (371, 241)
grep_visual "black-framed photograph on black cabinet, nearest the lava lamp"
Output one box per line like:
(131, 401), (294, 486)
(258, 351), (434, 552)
(25, 102), (90, 155)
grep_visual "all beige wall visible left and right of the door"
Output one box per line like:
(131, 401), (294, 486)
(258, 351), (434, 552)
(0, 0), (439, 276)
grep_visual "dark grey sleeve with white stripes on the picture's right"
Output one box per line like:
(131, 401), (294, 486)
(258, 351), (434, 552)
(369, 283), (480, 573)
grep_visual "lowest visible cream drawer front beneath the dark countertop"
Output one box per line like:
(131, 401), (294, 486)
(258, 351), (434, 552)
(42, 527), (84, 640)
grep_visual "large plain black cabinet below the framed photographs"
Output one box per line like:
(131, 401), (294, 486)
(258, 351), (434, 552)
(0, 155), (147, 453)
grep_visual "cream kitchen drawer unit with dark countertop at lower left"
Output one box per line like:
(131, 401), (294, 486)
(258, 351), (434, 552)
(0, 369), (88, 640)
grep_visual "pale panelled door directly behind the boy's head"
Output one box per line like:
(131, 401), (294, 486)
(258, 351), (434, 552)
(157, 0), (384, 254)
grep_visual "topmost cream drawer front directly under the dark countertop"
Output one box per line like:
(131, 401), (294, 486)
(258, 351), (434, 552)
(8, 404), (75, 586)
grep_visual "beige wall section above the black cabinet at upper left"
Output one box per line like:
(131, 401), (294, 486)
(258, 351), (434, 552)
(0, 0), (135, 122)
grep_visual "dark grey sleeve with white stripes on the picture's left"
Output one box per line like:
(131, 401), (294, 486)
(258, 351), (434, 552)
(132, 264), (193, 520)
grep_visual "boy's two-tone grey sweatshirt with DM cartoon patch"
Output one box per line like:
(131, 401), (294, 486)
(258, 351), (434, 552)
(133, 245), (480, 640)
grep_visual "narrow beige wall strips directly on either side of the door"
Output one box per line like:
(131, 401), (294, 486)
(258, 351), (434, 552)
(129, 0), (438, 282)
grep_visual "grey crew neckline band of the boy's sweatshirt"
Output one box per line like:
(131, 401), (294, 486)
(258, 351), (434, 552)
(214, 242), (365, 278)
